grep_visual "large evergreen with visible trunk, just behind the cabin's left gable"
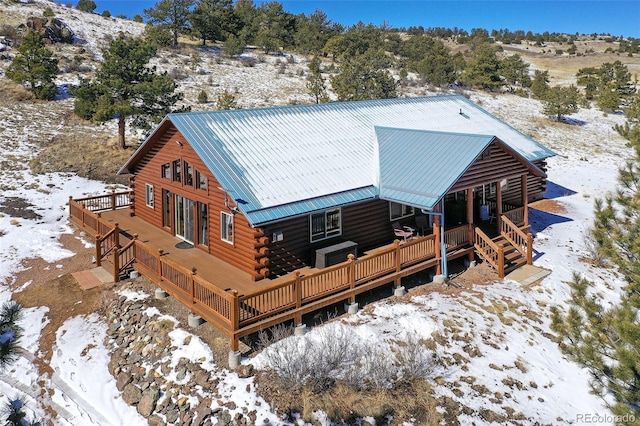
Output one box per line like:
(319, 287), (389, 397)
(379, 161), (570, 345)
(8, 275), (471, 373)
(74, 35), (182, 148)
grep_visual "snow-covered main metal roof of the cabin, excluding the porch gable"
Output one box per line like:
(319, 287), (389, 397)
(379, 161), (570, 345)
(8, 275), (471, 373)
(121, 95), (555, 225)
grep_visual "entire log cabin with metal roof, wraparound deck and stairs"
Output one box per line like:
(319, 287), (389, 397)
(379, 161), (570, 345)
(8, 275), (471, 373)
(70, 95), (554, 351)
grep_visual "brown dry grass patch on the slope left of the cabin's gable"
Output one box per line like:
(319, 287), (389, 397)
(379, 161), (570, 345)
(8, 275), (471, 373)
(29, 130), (134, 185)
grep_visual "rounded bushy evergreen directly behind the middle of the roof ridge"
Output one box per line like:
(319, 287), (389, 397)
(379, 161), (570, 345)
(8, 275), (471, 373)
(331, 50), (398, 101)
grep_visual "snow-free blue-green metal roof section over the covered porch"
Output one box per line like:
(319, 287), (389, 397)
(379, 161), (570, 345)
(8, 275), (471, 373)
(376, 127), (494, 210)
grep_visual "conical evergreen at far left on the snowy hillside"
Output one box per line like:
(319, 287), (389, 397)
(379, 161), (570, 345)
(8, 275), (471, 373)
(6, 31), (58, 99)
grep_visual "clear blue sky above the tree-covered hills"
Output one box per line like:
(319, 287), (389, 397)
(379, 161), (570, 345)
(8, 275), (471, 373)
(89, 0), (640, 38)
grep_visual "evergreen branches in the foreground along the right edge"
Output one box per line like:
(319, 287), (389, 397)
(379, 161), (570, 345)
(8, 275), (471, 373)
(552, 92), (640, 425)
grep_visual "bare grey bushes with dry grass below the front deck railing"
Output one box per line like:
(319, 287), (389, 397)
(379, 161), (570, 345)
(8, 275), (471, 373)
(256, 326), (440, 425)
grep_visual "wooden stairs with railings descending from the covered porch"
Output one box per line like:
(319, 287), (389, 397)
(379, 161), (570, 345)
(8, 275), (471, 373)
(474, 216), (533, 278)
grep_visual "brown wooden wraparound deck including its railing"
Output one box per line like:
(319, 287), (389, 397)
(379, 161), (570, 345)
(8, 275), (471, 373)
(69, 193), (531, 351)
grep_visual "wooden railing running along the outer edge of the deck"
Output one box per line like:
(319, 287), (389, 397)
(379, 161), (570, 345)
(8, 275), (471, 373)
(69, 194), (472, 350)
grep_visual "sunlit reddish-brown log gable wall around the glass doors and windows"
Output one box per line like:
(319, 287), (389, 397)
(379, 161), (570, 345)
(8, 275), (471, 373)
(126, 126), (268, 279)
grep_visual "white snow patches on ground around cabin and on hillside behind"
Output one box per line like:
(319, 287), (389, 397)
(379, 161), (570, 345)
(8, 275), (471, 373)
(0, 0), (630, 425)
